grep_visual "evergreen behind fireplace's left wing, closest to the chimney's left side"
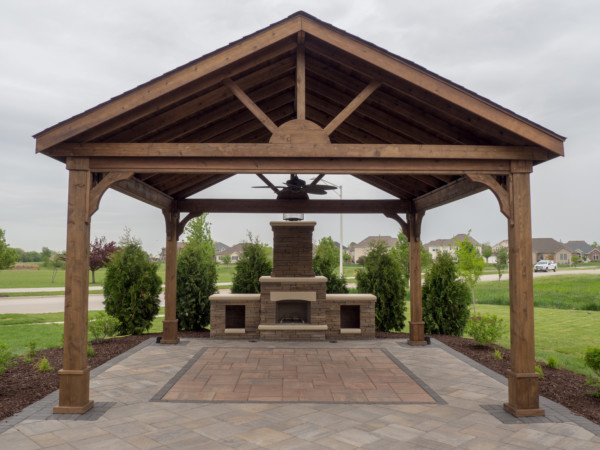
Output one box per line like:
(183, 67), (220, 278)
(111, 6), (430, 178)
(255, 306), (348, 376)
(231, 233), (273, 294)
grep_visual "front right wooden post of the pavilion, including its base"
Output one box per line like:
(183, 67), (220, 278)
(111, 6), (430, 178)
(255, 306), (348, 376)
(504, 163), (544, 417)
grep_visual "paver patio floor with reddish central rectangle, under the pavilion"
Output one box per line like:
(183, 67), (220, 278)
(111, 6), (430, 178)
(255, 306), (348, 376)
(0, 339), (600, 450)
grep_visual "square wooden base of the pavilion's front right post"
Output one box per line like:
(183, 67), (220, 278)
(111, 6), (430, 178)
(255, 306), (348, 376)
(504, 369), (545, 417)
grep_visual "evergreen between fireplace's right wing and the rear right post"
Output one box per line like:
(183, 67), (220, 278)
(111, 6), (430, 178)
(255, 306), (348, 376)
(356, 241), (406, 331)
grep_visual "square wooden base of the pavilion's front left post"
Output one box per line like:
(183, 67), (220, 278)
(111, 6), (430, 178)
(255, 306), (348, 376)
(53, 367), (94, 414)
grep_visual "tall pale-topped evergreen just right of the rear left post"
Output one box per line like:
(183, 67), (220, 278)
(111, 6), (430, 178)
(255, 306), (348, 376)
(177, 214), (217, 330)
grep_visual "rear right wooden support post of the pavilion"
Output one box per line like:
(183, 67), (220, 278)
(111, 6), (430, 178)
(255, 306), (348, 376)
(406, 213), (427, 345)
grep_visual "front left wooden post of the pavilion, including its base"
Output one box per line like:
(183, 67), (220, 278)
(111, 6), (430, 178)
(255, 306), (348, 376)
(54, 158), (94, 414)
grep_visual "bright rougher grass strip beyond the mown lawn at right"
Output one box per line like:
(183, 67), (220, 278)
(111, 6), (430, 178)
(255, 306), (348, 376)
(475, 274), (600, 311)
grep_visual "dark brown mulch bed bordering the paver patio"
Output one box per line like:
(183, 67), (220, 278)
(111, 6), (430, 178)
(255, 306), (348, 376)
(0, 331), (600, 425)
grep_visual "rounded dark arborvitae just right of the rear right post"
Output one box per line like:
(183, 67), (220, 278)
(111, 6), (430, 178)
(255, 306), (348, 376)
(423, 252), (471, 336)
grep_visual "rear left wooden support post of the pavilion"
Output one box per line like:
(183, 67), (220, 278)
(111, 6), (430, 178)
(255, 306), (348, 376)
(160, 209), (179, 344)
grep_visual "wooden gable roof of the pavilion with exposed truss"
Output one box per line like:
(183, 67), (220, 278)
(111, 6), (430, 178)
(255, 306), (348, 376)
(34, 11), (564, 209)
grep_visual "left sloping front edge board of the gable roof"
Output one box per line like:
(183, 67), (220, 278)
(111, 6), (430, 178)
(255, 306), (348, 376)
(35, 21), (302, 152)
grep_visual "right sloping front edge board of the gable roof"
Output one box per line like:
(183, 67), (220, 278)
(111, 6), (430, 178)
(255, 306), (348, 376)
(302, 18), (564, 155)
